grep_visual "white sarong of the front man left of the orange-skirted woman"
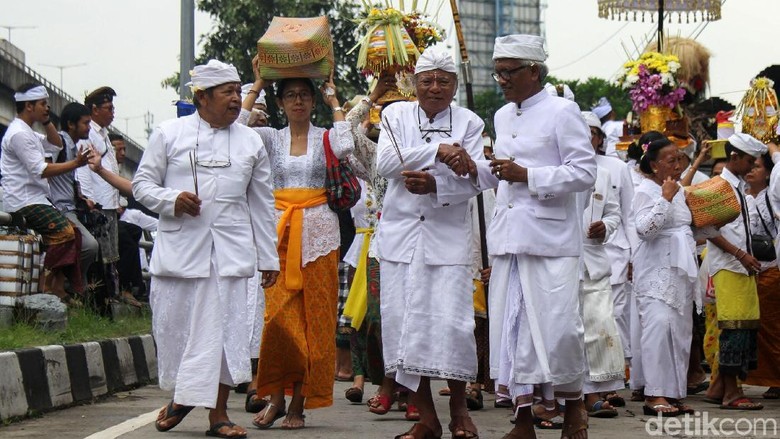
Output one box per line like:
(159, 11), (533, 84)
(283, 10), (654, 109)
(149, 250), (253, 408)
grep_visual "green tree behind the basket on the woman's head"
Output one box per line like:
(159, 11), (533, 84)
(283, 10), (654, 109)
(163, 0), (367, 127)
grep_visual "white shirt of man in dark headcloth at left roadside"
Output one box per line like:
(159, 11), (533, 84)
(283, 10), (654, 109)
(76, 121), (119, 209)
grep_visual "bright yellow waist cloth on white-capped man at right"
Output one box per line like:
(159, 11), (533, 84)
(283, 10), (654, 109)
(712, 270), (760, 329)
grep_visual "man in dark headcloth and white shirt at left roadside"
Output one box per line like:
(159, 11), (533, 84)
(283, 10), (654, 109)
(76, 87), (119, 305)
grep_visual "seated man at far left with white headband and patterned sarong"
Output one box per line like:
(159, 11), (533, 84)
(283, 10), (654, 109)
(0, 84), (91, 301)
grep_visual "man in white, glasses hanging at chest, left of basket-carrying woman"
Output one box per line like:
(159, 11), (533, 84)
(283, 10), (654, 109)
(133, 60), (279, 438)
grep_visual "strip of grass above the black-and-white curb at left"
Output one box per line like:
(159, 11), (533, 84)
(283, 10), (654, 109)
(0, 308), (152, 351)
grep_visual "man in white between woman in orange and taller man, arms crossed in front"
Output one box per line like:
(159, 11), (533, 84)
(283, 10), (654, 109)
(376, 49), (484, 439)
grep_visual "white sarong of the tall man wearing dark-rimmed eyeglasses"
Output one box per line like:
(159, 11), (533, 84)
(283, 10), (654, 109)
(489, 254), (586, 406)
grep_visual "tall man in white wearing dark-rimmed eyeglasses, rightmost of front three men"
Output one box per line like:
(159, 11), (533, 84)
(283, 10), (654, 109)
(477, 35), (596, 439)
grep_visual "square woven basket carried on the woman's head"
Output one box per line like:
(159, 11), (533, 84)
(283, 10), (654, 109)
(257, 17), (335, 79)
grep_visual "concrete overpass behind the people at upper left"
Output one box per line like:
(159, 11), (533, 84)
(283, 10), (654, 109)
(0, 38), (143, 175)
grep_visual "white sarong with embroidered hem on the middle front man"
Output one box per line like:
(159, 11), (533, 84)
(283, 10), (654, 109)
(379, 240), (477, 391)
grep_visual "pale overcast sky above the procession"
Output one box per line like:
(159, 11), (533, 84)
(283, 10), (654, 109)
(0, 0), (780, 145)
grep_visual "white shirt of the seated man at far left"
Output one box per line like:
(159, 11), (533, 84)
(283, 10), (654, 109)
(0, 118), (59, 212)
